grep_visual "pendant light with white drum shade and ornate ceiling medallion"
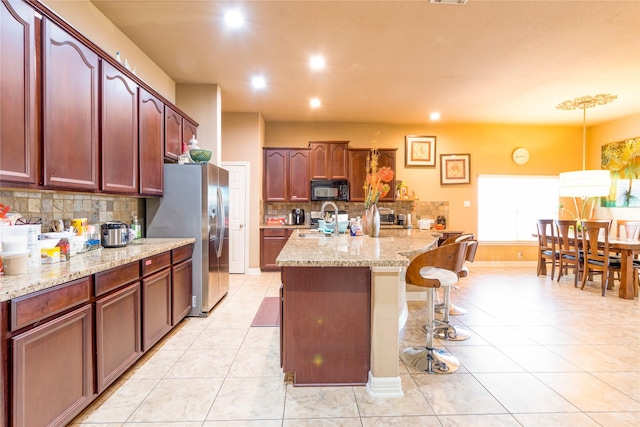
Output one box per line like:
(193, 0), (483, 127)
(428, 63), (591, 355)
(556, 94), (617, 199)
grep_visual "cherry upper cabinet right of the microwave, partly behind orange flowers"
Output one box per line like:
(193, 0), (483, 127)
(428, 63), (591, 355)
(349, 148), (396, 202)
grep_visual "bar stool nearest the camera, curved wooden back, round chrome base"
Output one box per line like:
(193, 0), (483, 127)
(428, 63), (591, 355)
(400, 241), (468, 374)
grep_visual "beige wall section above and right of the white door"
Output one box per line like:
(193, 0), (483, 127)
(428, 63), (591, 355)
(222, 113), (264, 269)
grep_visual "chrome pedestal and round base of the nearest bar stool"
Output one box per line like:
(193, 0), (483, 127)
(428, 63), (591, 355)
(400, 288), (460, 374)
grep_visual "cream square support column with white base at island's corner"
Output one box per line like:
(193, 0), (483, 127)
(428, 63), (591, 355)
(367, 267), (403, 397)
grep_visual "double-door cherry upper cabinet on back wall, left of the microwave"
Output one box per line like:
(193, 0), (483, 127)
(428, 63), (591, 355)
(263, 148), (311, 202)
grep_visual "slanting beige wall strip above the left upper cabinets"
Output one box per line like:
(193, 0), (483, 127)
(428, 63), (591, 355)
(42, 0), (177, 105)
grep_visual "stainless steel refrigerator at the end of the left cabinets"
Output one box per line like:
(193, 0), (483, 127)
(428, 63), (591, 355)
(146, 163), (229, 317)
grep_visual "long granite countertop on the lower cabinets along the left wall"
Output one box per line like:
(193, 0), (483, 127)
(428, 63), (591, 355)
(0, 237), (195, 301)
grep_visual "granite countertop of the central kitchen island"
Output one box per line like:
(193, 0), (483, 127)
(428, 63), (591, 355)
(276, 229), (438, 267)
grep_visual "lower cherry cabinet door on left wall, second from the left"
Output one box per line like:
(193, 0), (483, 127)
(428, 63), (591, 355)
(96, 282), (142, 393)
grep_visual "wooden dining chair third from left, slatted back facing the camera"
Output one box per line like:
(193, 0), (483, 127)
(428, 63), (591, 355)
(580, 219), (621, 296)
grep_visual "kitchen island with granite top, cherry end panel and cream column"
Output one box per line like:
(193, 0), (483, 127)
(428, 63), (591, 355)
(276, 229), (437, 397)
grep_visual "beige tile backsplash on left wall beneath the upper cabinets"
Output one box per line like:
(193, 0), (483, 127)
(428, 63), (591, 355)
(0, 190), (145, 232)
